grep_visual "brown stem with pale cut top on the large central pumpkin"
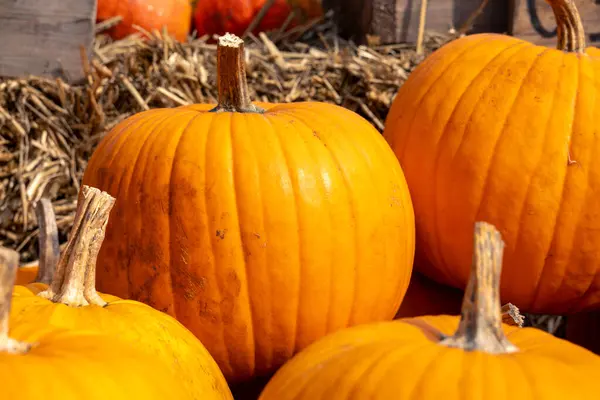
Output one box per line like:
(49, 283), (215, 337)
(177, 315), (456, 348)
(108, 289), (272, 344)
(211, 33), (265, 113)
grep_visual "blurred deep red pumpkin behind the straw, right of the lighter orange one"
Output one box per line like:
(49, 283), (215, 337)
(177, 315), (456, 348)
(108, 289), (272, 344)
(194, 0), (323, 36)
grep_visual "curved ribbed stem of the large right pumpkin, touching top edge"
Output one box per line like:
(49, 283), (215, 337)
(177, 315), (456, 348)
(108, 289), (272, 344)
(546, 0), (585, 53)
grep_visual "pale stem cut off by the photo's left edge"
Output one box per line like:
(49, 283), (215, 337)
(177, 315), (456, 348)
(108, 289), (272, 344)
(0, 247), (31, 354)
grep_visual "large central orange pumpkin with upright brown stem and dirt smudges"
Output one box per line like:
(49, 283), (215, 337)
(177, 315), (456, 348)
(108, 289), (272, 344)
(83, 35), (414, 383)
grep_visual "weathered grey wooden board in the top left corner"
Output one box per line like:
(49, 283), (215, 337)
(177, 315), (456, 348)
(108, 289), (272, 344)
(0, 0), (96, 82)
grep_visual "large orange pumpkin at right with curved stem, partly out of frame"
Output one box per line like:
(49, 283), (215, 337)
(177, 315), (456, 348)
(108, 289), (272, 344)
(384, 0), (600, 314)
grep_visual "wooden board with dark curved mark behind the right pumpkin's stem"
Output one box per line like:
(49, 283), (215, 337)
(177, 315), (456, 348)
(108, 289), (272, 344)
(511, 0), (600, 47)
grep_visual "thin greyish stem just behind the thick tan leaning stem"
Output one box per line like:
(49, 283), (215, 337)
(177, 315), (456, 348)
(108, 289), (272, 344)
(34, 198), (60, 285)
